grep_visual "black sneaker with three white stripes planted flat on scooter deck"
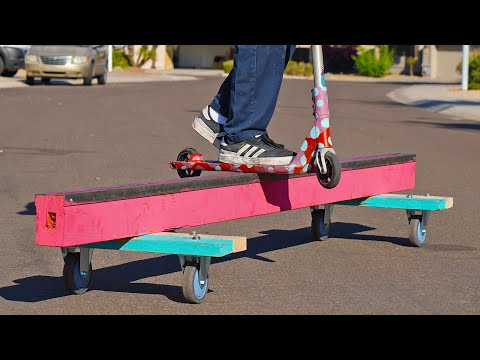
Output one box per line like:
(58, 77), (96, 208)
(218, 134), (297, 165)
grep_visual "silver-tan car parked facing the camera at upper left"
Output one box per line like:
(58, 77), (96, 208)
(25, 45), (108, 85)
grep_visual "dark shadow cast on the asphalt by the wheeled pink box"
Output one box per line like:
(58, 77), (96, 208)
(0, 222), (416, 303)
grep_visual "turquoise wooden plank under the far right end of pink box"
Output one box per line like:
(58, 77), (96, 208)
(335, 194), (453, 211)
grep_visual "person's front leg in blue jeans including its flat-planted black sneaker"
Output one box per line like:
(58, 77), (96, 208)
(218, 45), (295, 165)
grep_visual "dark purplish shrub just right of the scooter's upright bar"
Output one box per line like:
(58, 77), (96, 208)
(322, 45), (357, 74)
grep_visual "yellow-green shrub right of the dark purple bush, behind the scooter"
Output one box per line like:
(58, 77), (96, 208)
(353, 45), (394, 77)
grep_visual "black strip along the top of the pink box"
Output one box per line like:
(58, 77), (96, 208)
(50, 154), (415, 205)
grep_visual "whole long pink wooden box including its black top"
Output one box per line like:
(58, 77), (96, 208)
(35, 154), (415, 247)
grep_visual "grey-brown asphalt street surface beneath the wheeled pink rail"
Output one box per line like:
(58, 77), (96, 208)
(0, 78), (480, 314)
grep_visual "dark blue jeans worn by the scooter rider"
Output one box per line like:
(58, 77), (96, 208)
(210, 45), (296, 144)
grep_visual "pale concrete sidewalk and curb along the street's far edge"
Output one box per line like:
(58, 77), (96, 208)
(0, 69), (480, 121)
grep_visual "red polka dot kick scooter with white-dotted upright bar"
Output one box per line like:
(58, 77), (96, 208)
(170, 45), (342, 189)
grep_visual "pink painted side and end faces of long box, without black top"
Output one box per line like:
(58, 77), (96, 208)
(35, 161), (416, 247)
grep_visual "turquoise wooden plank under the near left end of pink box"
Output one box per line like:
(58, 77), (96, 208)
(82, 234), (233, 257)
